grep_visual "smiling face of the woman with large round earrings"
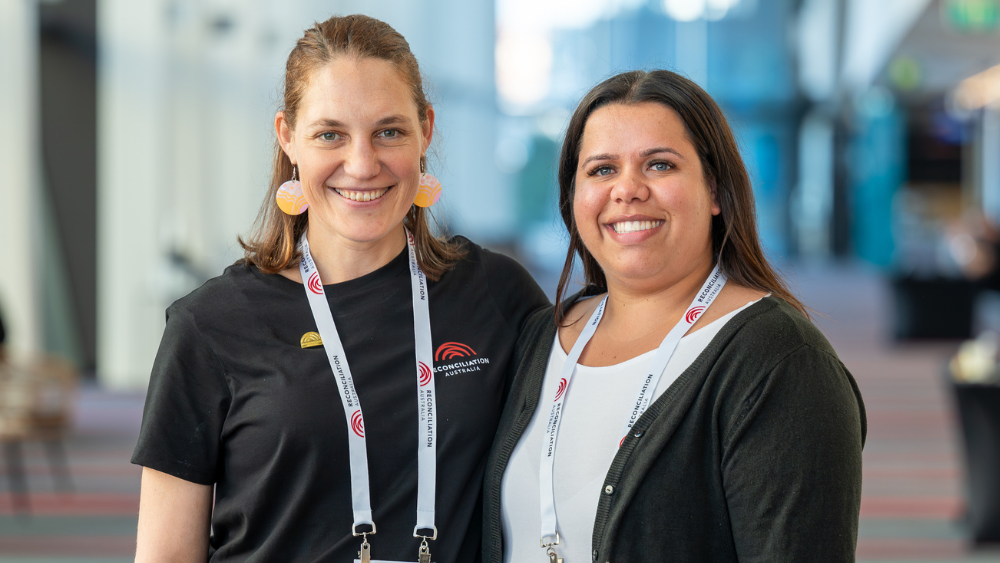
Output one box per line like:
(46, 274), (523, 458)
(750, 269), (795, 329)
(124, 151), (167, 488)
(275, 55), (434, 249)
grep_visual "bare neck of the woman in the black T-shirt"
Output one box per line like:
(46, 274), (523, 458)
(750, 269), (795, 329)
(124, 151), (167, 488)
(281, 225), (406, 284)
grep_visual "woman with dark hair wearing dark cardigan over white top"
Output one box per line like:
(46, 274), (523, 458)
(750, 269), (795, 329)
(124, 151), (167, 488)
(483, 70), (866, 563)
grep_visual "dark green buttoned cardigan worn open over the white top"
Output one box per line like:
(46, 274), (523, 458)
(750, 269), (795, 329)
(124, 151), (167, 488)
(483, 297), (866, 563)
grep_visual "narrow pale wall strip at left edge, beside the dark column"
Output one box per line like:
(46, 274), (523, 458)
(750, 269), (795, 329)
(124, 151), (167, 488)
(0, 0), (41, 355)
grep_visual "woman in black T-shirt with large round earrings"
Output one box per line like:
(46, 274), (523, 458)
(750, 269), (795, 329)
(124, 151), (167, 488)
(132, 15), (548, 563)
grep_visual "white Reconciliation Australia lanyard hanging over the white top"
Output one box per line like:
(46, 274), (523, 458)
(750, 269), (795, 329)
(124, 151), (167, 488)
(538, 264), (726, 561)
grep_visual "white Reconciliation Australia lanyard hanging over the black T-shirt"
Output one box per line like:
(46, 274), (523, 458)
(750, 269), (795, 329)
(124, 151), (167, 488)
(299, 231), (437, 560)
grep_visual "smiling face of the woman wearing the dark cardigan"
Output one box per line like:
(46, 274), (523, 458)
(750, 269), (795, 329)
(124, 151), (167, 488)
(573, 102), (720, 288)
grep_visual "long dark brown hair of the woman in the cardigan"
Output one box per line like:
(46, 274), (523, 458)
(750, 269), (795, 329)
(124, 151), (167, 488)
(556, 70), (809, 324)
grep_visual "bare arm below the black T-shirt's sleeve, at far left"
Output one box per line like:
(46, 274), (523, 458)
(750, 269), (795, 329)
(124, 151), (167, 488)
(135, 467), (212, 563)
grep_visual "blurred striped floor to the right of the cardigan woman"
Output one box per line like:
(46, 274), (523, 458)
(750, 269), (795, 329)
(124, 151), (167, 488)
(786, 264), (1000, 563)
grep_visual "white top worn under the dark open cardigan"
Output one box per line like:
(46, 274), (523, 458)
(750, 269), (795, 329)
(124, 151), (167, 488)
(500, 301), (756, 563)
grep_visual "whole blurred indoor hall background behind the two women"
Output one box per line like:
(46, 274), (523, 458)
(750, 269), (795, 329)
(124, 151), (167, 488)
(0, 0), (1000, 563)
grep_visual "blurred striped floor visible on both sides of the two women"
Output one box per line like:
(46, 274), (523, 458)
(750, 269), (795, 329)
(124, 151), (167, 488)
(0, 264), (1000, 563)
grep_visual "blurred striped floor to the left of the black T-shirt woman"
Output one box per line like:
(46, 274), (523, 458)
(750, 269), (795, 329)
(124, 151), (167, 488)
(0, 387), (143, 563)
